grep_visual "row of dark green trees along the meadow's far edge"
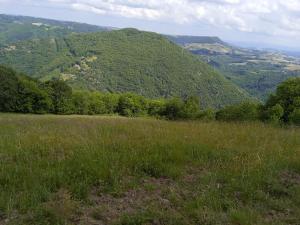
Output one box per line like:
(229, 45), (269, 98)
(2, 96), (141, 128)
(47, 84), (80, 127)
(0, 66), (300, 125)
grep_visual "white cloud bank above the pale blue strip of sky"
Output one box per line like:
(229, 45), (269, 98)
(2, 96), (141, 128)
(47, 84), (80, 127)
(0, 0), (300, 37)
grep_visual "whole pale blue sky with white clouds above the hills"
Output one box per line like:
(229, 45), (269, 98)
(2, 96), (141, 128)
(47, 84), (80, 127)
(0, 0), (300, 50)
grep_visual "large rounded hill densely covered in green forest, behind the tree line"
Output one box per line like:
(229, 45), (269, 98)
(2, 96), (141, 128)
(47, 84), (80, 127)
(0, 29), (249, 107)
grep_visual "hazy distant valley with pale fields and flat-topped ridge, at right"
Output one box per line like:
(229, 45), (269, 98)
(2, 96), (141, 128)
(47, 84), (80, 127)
(168, 36), (300, 100)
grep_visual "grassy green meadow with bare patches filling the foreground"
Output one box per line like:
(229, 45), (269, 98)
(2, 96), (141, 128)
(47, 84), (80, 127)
(0, 114), (300, 225)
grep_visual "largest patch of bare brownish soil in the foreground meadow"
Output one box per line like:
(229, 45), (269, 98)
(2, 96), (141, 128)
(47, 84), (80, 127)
(80, 178), (178, 224)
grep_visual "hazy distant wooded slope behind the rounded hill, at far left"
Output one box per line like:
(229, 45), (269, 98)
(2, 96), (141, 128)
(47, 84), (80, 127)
(0, 14), (112, 46)
